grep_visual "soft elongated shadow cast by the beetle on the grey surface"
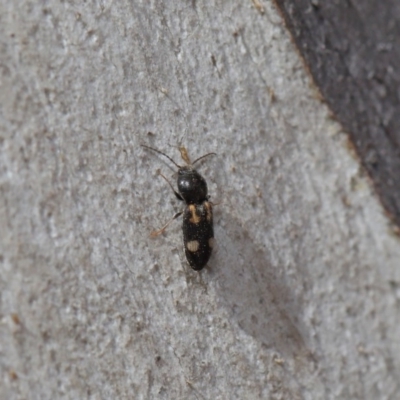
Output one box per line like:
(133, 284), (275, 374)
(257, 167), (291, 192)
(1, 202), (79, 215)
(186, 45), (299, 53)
(210, 212), (316, 373)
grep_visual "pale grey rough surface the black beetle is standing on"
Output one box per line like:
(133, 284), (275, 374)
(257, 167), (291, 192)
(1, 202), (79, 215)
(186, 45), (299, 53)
(0, 0), (400, 400)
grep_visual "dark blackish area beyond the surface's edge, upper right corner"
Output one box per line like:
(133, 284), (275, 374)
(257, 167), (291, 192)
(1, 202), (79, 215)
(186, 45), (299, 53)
(275, 0), (400, 226)
